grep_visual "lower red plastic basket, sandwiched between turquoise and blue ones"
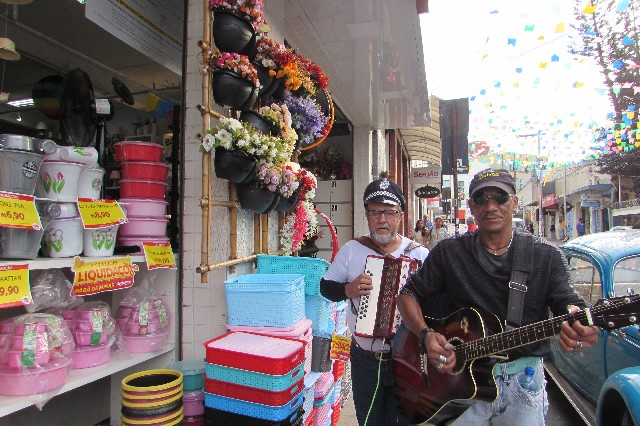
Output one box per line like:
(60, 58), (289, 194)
(204, 379), (304, 407)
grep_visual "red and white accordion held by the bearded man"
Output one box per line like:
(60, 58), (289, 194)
(354, 255), (418, 338)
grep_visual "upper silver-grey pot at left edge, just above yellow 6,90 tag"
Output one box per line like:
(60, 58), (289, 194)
(0, 149), (44, 195)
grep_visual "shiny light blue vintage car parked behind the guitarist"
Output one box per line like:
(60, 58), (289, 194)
(545, 230), (640, 425)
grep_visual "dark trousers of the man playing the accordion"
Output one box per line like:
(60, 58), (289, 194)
(351, 341), (409, 426)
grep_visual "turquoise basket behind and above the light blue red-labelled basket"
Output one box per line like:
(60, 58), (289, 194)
(256, 254), (330, 295)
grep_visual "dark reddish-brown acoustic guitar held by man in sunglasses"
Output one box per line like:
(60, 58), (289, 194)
(393, 295), (640, 424)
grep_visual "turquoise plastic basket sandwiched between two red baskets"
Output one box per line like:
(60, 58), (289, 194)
(204, 362), (304, 392)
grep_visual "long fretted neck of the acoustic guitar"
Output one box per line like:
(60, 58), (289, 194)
(455, 310), (591, 360)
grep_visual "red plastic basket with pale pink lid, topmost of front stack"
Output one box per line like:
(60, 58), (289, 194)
(204, 332), (306, 375)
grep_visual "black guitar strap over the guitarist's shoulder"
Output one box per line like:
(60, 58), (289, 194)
(506, 230), (533, 330)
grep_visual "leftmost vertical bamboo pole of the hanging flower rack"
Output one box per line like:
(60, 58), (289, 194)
(198, 0), (213, 283)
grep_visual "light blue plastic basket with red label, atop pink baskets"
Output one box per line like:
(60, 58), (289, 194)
(224, 274), (305, 327)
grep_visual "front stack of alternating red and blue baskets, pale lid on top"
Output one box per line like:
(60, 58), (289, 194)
(204, 332), (304, 426)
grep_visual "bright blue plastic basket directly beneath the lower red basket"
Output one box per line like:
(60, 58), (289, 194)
(204, 392), (303, 421)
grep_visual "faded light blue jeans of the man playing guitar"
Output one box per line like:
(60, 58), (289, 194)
(450, 363), (549, 426)
